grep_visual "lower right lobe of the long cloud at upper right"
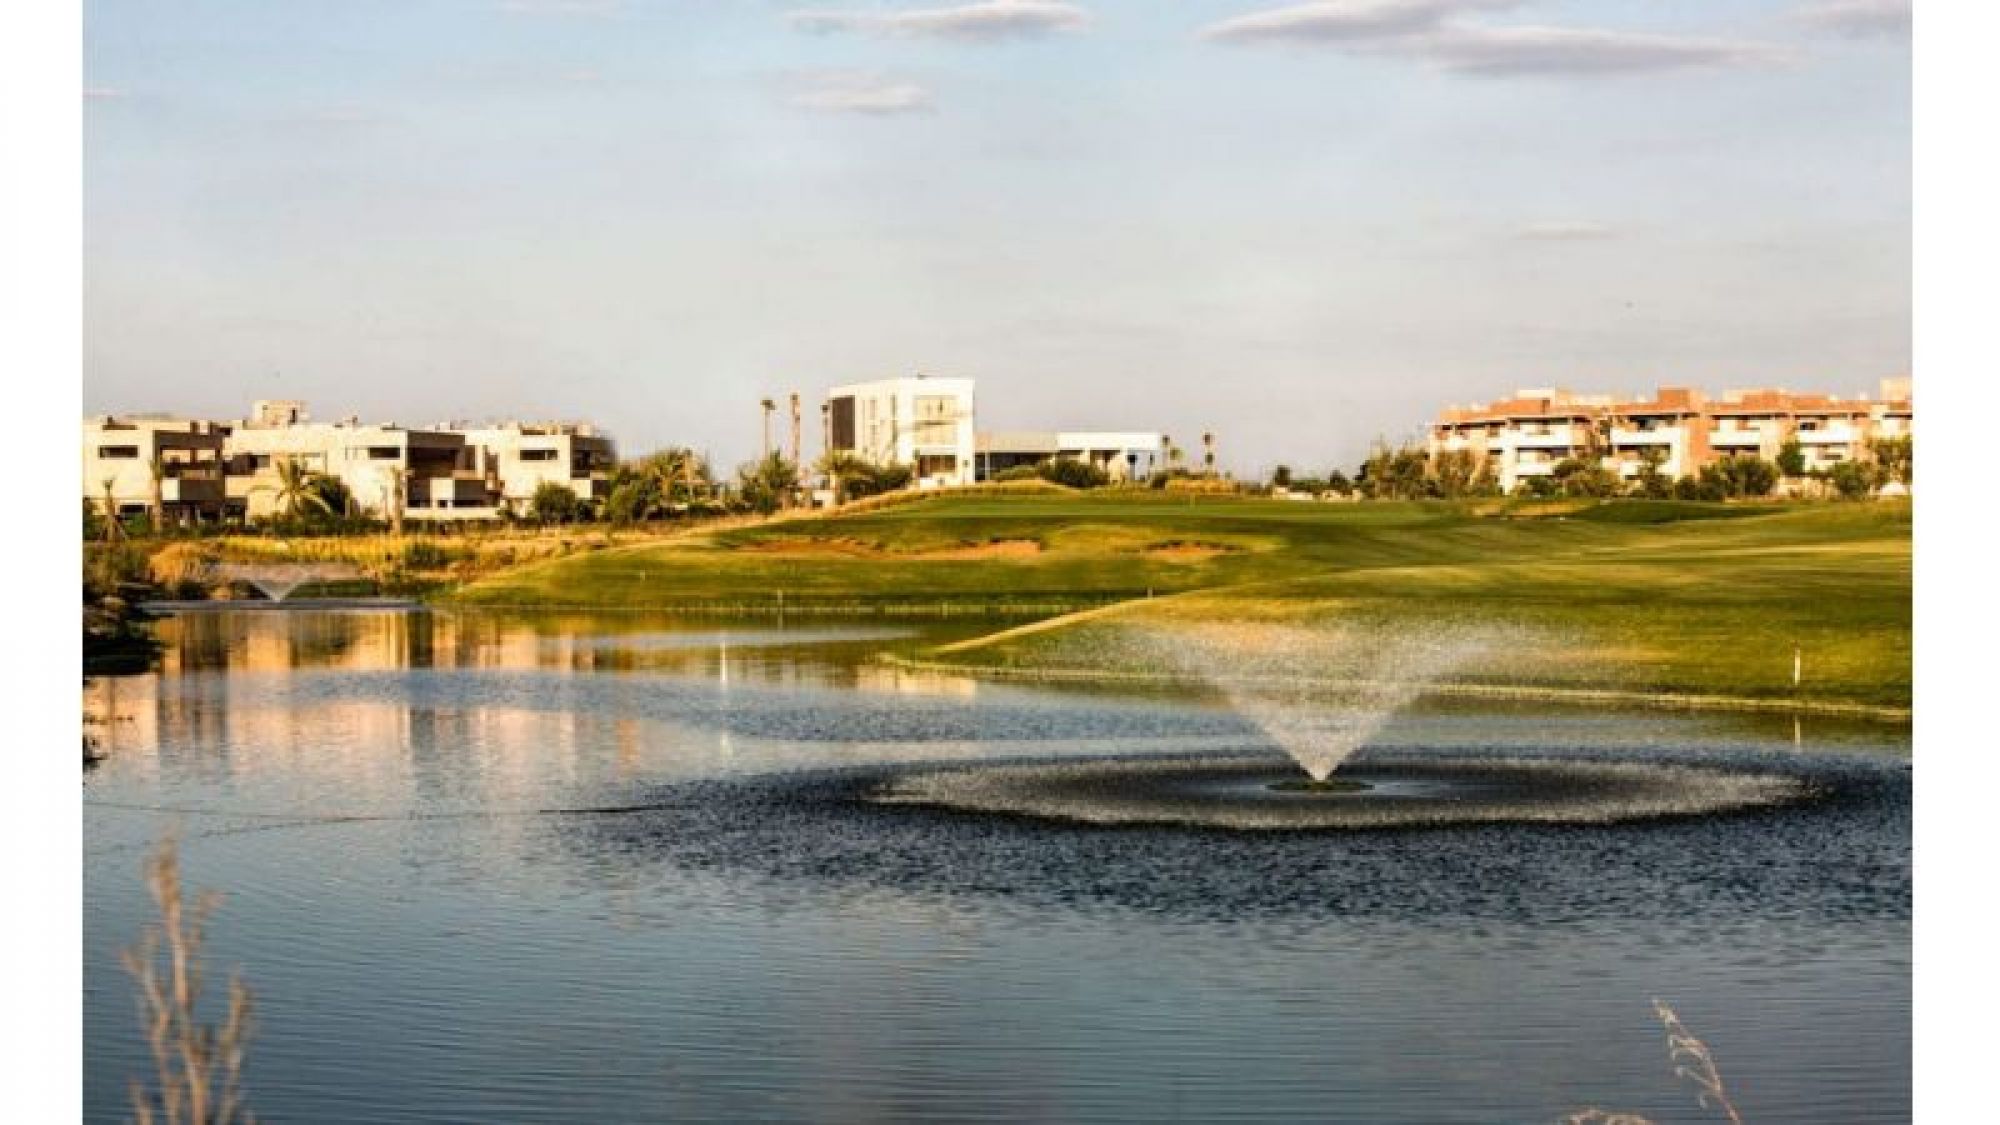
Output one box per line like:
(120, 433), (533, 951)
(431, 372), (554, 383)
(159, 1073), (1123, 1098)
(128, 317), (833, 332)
(1422, 26), (1786, 76)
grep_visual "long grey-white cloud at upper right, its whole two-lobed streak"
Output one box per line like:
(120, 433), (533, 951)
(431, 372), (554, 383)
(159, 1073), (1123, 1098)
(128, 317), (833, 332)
(1202, 0), (1786, 76)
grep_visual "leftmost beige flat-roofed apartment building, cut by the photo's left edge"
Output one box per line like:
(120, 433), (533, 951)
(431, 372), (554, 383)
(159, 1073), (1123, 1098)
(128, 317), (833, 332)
(82, 414), (228, 524)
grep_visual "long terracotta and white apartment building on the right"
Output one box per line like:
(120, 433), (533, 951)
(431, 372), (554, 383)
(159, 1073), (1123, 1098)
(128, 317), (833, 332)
(1430, 376), (1914, 492)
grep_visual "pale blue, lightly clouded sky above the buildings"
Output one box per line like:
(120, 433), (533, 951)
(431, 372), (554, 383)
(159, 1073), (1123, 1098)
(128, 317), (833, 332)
(82, 0), (1912, 474)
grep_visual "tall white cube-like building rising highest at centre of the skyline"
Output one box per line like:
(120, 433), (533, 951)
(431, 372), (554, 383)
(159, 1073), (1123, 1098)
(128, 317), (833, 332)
(826, 374), (976, 488)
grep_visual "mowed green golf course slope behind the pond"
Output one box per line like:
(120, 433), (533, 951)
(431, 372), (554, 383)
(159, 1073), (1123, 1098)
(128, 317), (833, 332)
(458, 492), (1910, 707)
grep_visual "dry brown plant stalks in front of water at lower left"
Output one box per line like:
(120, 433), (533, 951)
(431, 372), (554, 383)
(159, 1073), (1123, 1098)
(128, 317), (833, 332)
(124, 837), (256, 1125)
